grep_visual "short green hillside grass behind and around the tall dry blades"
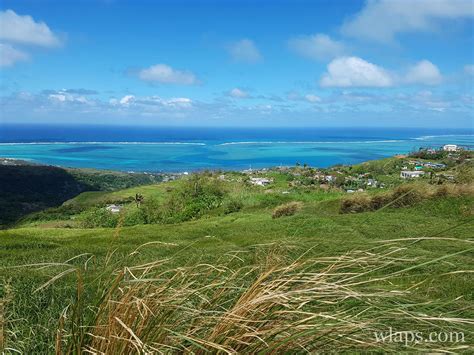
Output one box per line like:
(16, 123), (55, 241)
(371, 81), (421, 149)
(0, 170), (474, 353)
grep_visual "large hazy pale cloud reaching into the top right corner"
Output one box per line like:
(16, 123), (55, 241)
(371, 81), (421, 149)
(342, 0), (474, 42)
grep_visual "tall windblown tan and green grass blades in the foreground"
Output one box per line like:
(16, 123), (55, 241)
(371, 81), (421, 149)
(40, 244), (474, 354)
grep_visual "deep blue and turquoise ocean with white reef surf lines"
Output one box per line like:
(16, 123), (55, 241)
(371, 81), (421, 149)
(0, 124), (474, 172)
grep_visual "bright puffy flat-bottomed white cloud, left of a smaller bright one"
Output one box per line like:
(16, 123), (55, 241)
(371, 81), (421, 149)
(320, 57), (393, 87)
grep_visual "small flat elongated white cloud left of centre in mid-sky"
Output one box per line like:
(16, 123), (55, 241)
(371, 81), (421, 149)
(138, 64), (198, 85)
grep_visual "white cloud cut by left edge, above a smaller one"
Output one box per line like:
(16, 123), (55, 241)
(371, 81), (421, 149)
(0, 10), (60, 47)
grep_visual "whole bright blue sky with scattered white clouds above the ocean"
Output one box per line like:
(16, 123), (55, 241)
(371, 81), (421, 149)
(0, 0), (474, 129)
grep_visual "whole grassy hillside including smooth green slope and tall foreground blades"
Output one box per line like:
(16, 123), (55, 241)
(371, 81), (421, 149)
(0, 163), (474, 353)
